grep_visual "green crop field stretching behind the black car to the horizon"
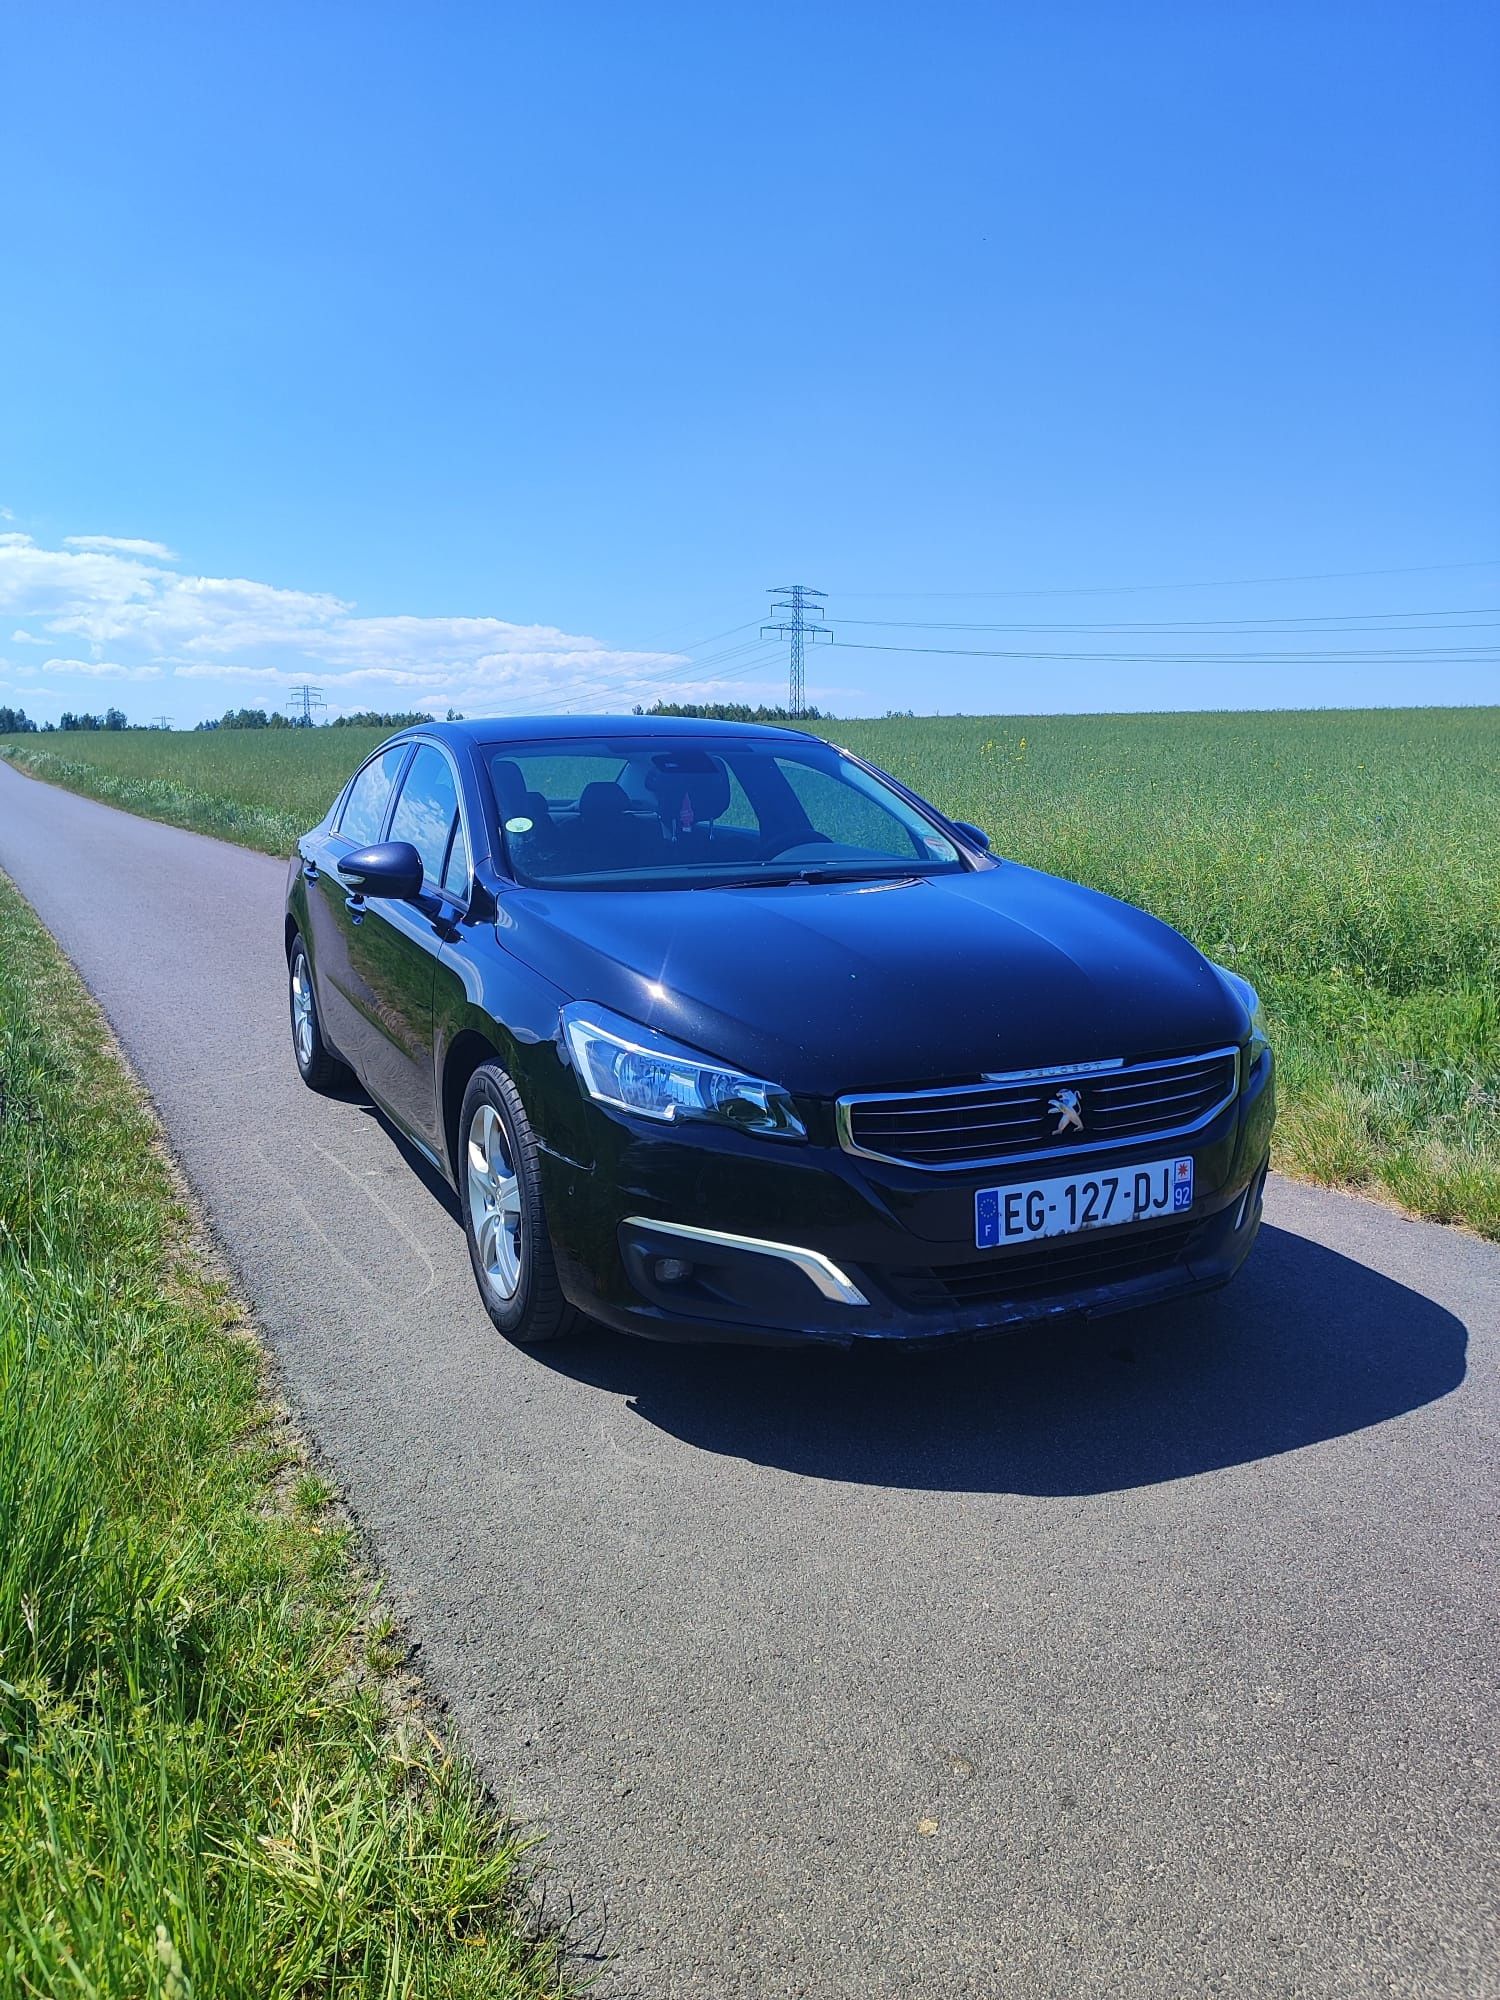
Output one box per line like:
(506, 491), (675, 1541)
(0, 708), (1500, 1236)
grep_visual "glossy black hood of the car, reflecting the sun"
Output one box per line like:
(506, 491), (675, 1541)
(498, 862), (1248, 1096)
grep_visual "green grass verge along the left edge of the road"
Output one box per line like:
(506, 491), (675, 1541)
(0, 878), (564, 2000)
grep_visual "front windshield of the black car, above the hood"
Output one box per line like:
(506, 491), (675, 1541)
(484, 736), (966, 888)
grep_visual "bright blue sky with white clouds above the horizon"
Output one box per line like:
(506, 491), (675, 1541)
(0, 0), (1500, 720)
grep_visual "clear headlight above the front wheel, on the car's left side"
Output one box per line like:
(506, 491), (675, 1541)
(562, 1002), (808, 1138)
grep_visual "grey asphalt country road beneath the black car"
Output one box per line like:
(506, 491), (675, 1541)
(0, 764), (1500, 2000)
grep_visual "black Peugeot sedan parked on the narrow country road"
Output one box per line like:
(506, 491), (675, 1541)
(286, 716), (1274, 1342)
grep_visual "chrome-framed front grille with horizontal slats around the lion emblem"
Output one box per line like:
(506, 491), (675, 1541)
(838, 1048), (1238, 1170)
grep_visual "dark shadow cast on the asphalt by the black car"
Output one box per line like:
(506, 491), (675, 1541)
(532, 1228), (1466, 1496)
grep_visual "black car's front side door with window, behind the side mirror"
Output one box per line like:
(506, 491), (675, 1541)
(348, 742), (468, 1156)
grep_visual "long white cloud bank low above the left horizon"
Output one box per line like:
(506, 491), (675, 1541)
(0, 534), (692, 714)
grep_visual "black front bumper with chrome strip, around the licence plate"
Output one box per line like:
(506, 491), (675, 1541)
(542, 1056), (1274, 1346)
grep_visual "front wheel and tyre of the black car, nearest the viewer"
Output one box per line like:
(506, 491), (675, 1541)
(454, 1062), (580, 1348)
